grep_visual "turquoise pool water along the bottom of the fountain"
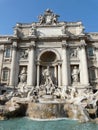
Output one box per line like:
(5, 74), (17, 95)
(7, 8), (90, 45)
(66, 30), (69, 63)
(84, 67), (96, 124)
(0, 118), (98, 130)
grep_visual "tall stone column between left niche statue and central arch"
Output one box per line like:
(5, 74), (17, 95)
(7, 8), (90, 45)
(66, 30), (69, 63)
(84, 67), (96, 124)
(27, 42), (36, 86)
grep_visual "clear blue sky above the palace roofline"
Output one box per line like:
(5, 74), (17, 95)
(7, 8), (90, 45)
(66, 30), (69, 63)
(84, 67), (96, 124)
(0, 0), (98, 35)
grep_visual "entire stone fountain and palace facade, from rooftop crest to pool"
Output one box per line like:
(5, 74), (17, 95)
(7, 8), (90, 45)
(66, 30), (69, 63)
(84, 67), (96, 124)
(0, 9), (98, 120)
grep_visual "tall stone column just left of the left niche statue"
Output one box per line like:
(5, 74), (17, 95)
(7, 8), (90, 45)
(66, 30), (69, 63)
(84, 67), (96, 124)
(10, 42), (17, 86)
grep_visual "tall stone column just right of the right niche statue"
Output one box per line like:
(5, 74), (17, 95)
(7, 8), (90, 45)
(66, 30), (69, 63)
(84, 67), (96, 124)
(80, 40), (89, 85)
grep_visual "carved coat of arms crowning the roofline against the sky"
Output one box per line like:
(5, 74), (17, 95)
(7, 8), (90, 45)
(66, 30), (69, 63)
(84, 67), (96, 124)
(38, 9), (59, 25)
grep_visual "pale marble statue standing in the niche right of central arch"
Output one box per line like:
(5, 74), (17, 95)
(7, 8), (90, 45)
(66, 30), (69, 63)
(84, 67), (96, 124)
(72, 66), (80, 82)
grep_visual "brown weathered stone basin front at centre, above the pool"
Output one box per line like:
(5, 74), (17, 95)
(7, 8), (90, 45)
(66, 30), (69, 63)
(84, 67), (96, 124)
(26, 102), (66, 119)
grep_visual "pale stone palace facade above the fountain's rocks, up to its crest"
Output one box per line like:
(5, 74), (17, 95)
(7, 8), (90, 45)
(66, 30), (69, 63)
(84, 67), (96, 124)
(0, 9), (98, 94)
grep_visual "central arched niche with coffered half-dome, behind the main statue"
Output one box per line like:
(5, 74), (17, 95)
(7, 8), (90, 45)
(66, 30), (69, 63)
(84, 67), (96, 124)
(37, 48), (61, 86)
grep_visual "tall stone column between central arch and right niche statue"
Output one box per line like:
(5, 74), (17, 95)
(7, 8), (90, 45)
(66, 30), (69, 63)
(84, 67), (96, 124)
(62, 41), (69, 87)
